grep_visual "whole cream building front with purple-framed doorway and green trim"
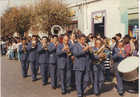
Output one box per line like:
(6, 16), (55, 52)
(68, 0), (139, 38)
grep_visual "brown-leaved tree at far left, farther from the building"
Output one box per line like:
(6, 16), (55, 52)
(1, 5), (32, 36)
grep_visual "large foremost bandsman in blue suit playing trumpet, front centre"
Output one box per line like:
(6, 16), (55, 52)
(73, 34), (90, 97)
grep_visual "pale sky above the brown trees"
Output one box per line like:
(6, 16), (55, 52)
(0, 0), (81, 16)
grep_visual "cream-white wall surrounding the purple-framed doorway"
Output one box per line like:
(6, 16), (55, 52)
(69, 0), (125, 38)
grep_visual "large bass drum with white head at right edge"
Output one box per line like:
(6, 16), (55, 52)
(118, 56), (139, 81)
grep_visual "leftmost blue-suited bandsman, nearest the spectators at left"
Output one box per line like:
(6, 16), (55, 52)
(19, 39), (29, 78)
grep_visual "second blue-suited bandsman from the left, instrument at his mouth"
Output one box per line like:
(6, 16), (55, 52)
(27, 35), (39, 82)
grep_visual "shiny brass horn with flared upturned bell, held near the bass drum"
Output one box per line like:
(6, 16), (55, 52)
(89, 38), (112, 65)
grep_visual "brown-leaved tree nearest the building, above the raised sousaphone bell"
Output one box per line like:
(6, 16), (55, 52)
(32, 0), (71, 35)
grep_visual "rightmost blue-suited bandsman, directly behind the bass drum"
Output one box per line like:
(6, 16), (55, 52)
(112, 41), (126, 96)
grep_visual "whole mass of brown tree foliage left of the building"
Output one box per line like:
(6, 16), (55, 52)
(1, 0), (71, 36)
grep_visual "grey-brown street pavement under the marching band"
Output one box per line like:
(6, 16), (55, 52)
(1, 56), (139, 97)
